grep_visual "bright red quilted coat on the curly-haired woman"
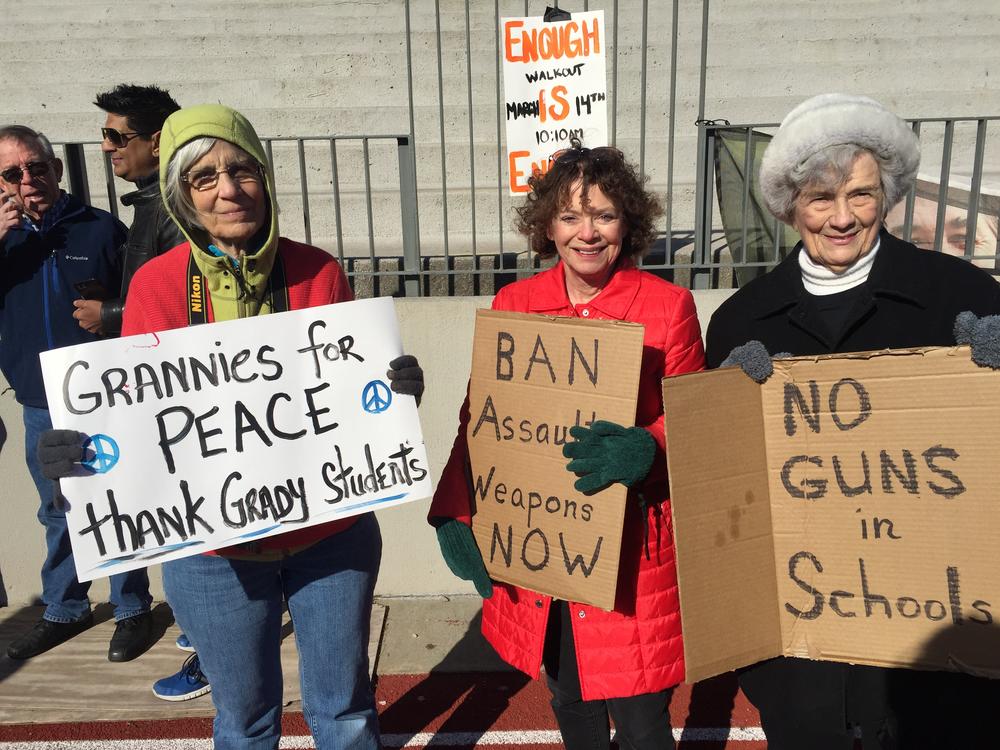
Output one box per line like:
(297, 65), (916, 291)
(429, 263), (705, 700)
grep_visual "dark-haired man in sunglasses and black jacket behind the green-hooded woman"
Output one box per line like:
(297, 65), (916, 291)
(73, 83), (184, 336)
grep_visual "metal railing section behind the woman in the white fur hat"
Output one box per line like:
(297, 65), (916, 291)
(691, 116), (1000, 288)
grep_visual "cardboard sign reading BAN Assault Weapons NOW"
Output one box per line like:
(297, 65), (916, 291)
(468, 310), (643, 609)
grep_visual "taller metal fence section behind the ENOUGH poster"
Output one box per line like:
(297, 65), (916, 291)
(394, 0), (709, 289)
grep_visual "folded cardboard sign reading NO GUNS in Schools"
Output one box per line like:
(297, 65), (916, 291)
(664, 347), (1000, 681)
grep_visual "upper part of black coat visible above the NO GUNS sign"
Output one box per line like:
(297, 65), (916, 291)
(705, 231), (1000, 368)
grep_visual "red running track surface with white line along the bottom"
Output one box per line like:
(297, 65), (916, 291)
(0, 673), (766, 750)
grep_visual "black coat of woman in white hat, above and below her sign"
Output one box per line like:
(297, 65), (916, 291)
(705, 231), (1000, 750)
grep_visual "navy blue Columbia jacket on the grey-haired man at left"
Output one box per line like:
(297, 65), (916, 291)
(0, 191), (126, 409)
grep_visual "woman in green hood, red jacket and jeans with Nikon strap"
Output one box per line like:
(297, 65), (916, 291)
(116, 105), (423, 750)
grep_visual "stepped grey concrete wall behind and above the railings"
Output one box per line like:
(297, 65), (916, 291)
(0, 0), (1000, 255)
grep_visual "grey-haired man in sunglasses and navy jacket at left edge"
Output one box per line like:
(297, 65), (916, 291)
(0, 125), (151, 661)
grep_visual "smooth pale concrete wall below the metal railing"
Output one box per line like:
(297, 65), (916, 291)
(0, 291), (730, 606)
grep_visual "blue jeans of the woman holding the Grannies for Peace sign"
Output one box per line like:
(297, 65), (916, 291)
(163, 513), (382, 750)
